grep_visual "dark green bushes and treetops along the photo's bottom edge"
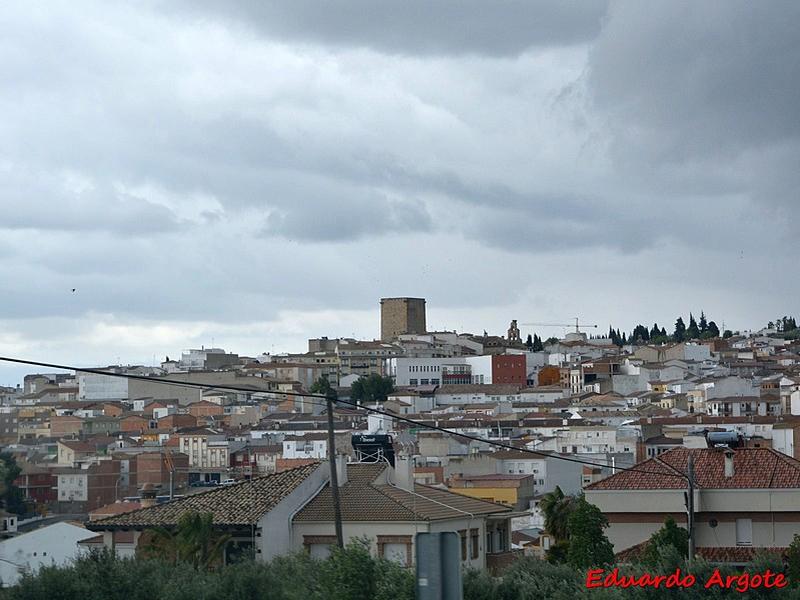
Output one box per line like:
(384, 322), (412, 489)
(0, 544), (800, 600)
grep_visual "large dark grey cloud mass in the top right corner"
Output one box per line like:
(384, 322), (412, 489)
(587, 0), (800, 210)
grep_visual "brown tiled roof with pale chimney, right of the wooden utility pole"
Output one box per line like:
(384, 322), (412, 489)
(295, 463), (511, 521)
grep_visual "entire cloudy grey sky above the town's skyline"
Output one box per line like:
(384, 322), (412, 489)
(0, 0), (800, 384)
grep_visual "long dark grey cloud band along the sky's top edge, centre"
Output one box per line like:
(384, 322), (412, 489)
(177, 0), (607, 56)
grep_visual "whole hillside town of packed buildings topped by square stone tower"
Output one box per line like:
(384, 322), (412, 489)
(0, 298), (800, 582)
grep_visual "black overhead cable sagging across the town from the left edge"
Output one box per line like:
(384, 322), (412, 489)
(0, 356), (687, 479)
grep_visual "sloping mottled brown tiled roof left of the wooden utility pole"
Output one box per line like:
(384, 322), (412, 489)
(87, 463), (319, 531)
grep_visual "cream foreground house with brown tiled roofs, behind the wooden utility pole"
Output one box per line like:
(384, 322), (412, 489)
(88, 457), (514, 568)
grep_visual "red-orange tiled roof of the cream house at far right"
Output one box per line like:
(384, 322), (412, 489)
(585, 448), (800, 490)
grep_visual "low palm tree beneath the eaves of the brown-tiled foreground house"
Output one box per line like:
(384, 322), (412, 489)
(138, 512), (231, 569)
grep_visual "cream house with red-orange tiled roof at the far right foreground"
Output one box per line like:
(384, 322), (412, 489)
(585, 447), (800, 562)
